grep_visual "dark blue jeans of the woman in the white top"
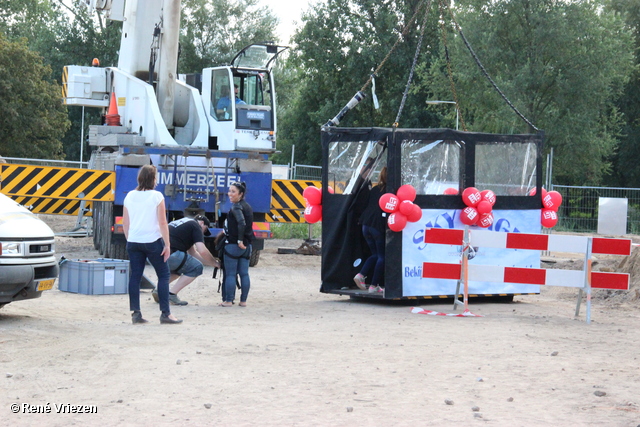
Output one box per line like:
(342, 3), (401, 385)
(127, 238), (171, 316)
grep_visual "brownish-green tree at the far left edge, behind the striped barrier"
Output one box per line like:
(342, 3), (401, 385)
(0, 33), (70, 159)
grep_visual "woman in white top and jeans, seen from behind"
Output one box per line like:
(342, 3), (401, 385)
(123, 165), (182, 324)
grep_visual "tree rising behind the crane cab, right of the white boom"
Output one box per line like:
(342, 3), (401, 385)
(178, 0), (278, 73)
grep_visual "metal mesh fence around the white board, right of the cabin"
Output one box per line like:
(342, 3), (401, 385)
(553, 185), (640, 234)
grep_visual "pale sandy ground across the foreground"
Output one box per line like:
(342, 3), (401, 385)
(0, 219), (640, 427)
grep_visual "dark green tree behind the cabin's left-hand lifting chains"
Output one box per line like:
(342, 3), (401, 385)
(274, 0), (439, 165)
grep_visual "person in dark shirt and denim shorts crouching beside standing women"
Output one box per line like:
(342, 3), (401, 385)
(151, 215), (220, 305)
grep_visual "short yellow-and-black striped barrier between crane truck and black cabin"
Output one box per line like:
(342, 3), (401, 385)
(267, 179), (321, 223)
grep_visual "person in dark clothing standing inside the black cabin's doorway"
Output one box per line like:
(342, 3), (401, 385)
(353, 166), (387, 293)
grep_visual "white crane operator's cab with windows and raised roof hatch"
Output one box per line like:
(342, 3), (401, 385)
(202, 43), (287, 153)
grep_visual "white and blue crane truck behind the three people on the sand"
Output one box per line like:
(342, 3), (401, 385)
(63, 0), (287, 266)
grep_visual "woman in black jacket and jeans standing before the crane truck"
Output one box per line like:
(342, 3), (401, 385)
(220, 182), (253, 307)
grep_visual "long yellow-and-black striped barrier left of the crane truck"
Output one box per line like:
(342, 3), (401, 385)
(0, 164), (116, 203)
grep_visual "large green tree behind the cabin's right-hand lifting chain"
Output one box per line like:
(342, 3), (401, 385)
(423, 0), (633, 184)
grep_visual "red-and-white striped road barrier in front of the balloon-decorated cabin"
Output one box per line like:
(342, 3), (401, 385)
(422, 231), (632, 324)
